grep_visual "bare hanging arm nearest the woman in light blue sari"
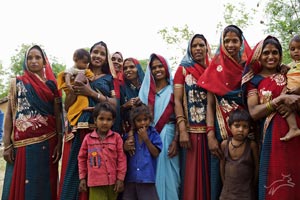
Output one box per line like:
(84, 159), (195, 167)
(174, 84), (191, 148)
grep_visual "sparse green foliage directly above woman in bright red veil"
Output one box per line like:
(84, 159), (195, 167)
(217, 2), (257, 32)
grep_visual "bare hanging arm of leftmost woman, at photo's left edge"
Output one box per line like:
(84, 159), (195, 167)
(3, 99), (15, 163)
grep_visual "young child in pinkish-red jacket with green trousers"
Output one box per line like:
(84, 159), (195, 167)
(78, 102), (127, 199)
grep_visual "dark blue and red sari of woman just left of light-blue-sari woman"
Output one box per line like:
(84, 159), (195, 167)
(120, 58), (144, 133)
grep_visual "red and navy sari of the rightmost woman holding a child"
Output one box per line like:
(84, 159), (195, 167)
(243, 36), (300, 200)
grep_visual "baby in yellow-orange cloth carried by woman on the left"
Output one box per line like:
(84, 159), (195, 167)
(57, 49), (94, 127)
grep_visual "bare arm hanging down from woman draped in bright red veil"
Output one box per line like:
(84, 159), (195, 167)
(206, 92), (223, 159)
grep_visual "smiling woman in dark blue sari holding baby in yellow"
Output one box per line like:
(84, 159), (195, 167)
(59, 41), (120, 199)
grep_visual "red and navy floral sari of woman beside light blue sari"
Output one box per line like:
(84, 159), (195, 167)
(174, 34), (210, 200)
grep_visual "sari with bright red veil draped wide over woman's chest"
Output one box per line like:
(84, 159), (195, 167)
(198, 25), (251, 199)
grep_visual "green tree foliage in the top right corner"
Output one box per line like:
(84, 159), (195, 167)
(261, 0), (300, 63)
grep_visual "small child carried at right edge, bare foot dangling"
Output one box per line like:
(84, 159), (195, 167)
(280, 35), (300, 141)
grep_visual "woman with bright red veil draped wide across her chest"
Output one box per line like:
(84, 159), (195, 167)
(198, 25), (251, 200)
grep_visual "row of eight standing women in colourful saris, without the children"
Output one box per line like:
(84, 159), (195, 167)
(2, 25), (300, 200)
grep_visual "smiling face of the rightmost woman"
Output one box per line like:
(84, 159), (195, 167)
(259, 44), (281, 71)
